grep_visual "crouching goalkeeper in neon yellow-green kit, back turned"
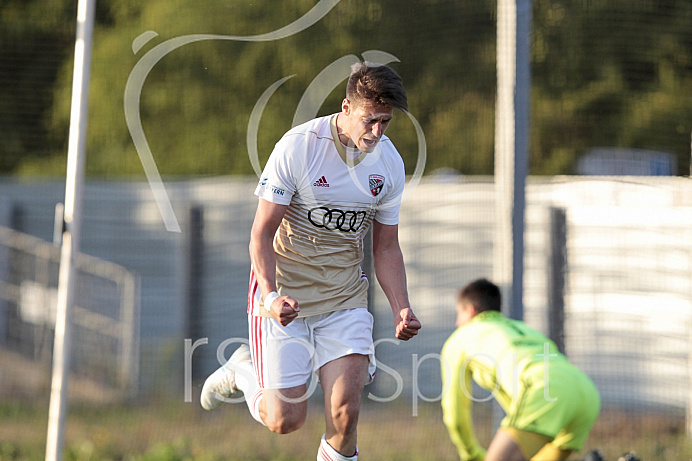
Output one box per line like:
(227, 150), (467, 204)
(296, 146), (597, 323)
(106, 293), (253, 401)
(442, 279), (600, 461)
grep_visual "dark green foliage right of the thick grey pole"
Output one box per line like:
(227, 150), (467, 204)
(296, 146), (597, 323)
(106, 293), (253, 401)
(531, 0), (692, 174)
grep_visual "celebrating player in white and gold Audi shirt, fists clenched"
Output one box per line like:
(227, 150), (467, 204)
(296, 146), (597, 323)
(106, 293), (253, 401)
(201, 62), (421, 461)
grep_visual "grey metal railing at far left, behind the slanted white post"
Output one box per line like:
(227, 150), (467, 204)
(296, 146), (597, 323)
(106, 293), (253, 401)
(0, 223), (139, 401)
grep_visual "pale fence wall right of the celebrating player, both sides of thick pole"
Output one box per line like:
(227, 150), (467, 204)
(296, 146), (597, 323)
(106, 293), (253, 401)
(374, 177), (692, 428)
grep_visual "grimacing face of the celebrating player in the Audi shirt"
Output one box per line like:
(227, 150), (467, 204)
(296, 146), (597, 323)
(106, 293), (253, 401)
(340, 99), (394, 153)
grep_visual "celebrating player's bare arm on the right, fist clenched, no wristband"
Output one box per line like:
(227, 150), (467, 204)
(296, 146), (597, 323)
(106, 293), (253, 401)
(372, 220), (421, 341)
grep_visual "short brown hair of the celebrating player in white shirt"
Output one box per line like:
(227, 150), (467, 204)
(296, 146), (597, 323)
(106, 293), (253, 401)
(346, 61), (408, 112)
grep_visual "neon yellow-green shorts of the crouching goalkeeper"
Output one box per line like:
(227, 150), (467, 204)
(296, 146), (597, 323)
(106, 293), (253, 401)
(502, 362), (601, 452)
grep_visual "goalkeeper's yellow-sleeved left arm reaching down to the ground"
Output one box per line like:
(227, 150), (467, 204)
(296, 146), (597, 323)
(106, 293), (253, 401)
(441, 336), (485, 461)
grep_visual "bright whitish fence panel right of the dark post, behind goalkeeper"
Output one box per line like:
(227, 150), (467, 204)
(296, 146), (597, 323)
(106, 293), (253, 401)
(565, 202), (692, 409)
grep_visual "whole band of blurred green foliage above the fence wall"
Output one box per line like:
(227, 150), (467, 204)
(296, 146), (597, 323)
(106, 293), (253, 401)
(0, 0), (692, 177)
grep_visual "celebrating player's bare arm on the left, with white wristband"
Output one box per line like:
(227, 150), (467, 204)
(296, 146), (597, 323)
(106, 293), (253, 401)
(250, 199), (300, 326)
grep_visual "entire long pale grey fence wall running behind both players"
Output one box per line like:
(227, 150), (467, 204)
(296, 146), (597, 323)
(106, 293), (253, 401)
(0, 176), (692, 432)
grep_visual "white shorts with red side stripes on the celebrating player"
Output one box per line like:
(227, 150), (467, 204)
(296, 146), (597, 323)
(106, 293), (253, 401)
(248, 308), (376, 389)
